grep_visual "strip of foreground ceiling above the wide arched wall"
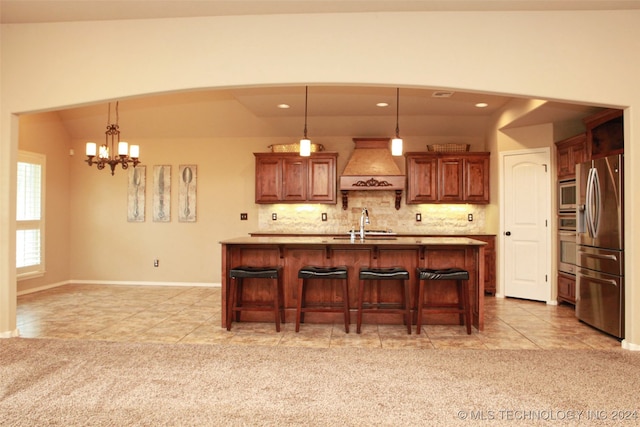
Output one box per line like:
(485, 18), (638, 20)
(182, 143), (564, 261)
(0, 0), (640, 24)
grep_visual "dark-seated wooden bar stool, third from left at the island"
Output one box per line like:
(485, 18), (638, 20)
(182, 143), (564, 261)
(356, 267), (411, 334)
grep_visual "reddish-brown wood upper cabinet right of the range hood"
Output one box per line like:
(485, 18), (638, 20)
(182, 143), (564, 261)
(405, 152), (489, 204)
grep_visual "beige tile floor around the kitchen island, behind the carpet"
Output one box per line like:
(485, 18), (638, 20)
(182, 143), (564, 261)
(17, 284), (620, 350)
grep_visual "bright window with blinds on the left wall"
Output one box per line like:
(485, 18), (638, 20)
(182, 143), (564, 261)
(16, 151), (45, 279)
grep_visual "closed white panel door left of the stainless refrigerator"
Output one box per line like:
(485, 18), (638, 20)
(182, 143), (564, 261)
(502, 149), (551, 302)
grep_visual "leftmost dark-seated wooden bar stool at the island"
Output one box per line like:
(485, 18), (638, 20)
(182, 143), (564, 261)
(227, 265), (284, 332)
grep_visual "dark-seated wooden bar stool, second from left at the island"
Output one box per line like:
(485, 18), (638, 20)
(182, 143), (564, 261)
(296, 265), (350, 333)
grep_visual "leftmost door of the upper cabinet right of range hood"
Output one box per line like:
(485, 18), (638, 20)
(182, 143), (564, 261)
(407, 156), (438, 204)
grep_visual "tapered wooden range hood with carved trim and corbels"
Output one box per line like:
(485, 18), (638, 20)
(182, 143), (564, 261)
(340, 138), (405, 210)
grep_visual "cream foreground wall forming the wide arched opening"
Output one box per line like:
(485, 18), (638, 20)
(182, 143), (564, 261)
(0, 11), (640, 346)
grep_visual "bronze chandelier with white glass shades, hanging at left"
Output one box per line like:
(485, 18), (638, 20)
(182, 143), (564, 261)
(85, 102), (140, 175)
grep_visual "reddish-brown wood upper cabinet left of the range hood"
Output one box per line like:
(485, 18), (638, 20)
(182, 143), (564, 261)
(254, 152), (338, 203)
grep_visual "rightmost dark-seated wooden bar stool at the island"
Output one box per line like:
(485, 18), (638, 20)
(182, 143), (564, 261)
(416, 268), (471, 334)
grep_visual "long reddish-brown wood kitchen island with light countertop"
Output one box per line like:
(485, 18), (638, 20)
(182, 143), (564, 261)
(220, 236), (486, 330)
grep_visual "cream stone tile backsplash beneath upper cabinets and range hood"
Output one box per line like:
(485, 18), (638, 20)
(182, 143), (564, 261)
(258, 191), (485, 234)
